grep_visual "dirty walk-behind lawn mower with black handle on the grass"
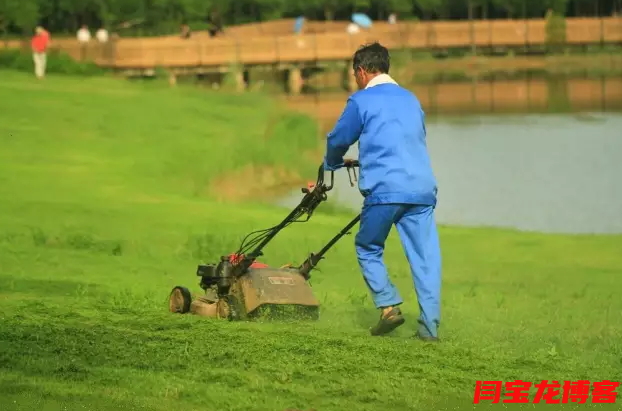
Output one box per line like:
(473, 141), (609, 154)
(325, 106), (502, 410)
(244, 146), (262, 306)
(169, 160), (361, 321)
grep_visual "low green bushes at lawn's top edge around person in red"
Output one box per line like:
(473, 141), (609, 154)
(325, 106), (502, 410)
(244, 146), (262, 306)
(0, 49), (104, 76)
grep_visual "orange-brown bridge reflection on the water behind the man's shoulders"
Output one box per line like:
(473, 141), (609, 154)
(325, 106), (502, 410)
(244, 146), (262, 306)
(284, 72), (622, 134)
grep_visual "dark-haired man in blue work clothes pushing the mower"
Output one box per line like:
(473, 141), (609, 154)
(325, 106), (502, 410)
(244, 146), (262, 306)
(324, 43), (441, 341)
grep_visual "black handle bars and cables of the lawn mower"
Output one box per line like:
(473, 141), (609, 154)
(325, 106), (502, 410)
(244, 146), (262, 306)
(234, 159), (360, 275)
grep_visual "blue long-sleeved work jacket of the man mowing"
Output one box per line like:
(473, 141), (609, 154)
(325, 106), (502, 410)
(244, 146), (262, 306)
(324, 75), (437, 206)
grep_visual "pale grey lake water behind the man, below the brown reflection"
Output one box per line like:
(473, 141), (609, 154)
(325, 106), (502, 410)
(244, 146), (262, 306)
(279, 112), (622, 233)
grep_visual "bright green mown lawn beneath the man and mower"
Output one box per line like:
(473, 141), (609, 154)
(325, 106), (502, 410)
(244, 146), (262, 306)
(0, 72), (622, 411)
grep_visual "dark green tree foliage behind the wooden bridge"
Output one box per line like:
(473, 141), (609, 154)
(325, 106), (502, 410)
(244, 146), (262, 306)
(0, 0), (618, 35)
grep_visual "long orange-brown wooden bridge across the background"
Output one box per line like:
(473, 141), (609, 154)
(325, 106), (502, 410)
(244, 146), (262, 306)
(0, 17), (622, 91)
